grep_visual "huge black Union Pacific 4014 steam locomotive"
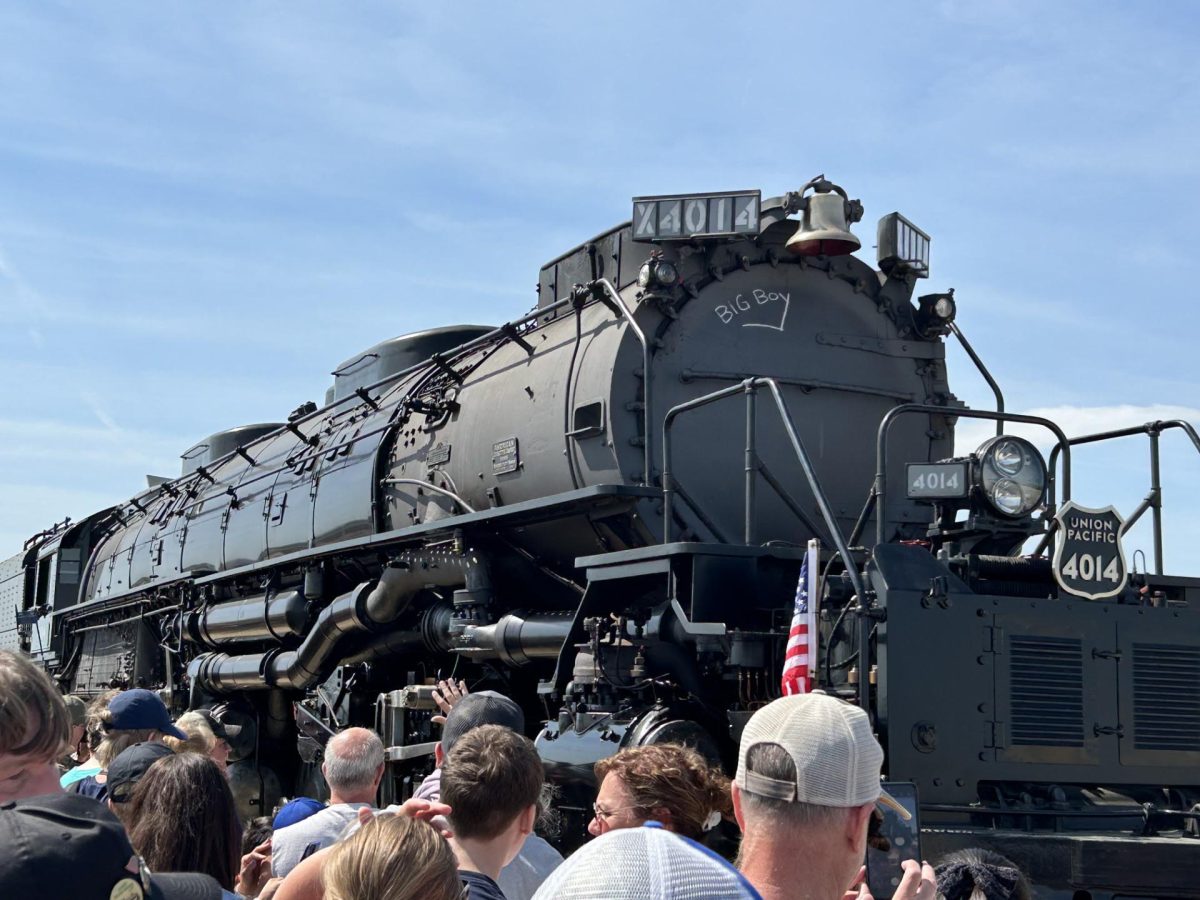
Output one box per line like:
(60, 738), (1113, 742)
(0, 176), (1200, 898)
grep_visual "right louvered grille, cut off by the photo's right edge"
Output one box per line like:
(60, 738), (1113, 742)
(1133, 643), (1200, 751)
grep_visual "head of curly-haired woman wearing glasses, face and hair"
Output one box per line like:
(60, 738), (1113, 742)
(588, 744), (733, 840)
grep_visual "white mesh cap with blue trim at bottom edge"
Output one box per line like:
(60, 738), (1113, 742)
(534, 826), (761, 900)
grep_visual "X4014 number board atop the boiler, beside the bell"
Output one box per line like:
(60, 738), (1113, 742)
(634, 191), (762, 241)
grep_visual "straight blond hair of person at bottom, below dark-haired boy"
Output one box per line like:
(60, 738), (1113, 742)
(320, 812), (462, 900)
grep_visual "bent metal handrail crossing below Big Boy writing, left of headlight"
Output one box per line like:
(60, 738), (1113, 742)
(662, 378), (871, 710)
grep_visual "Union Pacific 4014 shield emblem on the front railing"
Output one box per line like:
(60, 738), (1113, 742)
(1054, 500), (1128, 600)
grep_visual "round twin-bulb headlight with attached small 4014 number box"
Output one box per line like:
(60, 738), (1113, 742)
(907, 434), (1049, 520)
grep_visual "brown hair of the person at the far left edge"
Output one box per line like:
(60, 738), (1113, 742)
(0, 650), (71, 760)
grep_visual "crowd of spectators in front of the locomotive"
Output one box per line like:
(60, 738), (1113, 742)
(0, 652), (1030, 900)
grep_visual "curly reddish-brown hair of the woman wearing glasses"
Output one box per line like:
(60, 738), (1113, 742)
(595, 744), (733, 840)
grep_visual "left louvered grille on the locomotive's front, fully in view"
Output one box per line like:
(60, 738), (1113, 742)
(1008, 637), (1084, 746)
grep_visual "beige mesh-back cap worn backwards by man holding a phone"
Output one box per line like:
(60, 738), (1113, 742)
(734, 692), (912, 820)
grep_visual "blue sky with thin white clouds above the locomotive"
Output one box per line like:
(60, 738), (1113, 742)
(0, 0), (1200, 574)
